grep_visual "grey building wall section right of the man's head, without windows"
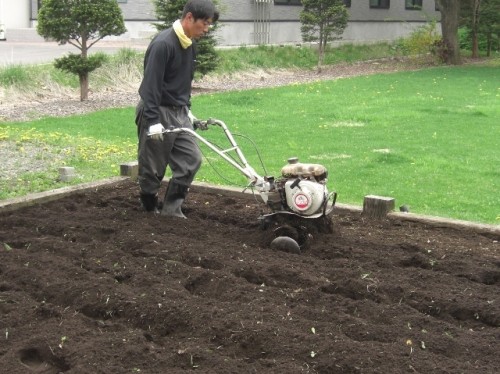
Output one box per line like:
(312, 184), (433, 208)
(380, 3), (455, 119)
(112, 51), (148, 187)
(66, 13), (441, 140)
(218, 0), (440, 45)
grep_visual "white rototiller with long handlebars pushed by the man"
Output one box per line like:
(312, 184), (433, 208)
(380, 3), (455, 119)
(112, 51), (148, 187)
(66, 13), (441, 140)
(160, 119), (337, 252)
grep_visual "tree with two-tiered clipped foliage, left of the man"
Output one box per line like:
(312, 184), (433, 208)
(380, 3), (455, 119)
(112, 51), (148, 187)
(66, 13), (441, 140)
(37, 0), (126, 101)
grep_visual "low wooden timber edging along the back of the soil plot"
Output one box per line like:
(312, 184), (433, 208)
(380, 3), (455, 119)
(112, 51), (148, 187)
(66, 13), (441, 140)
(0, 176), (500, 235)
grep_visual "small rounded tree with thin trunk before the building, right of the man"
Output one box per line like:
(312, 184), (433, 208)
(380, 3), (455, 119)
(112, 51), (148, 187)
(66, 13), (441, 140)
(300, 0), (349, 72)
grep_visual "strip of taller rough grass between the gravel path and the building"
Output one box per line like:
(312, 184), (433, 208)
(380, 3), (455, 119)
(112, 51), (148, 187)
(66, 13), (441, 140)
(0, 43), (400, 91)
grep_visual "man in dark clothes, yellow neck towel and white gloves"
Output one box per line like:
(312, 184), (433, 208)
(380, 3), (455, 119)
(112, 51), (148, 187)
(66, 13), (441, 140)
(135, 0), (219, 218)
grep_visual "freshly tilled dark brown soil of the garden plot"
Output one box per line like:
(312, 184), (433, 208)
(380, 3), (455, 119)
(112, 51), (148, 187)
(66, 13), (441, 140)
(0, 180), (500, 374)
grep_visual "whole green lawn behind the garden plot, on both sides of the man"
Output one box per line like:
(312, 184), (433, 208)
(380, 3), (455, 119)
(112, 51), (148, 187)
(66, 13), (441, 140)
(0, 47), (500, 224)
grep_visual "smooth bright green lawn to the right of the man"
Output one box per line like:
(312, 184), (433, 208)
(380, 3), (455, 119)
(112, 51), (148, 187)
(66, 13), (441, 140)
(195, 61), (500, 223)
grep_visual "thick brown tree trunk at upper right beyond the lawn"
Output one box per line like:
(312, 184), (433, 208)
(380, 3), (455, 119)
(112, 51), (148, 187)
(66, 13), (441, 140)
(437, 0), (461, 65)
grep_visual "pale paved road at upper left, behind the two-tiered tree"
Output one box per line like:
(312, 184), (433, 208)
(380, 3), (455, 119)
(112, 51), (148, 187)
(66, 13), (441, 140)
(0, 40), (147, 66)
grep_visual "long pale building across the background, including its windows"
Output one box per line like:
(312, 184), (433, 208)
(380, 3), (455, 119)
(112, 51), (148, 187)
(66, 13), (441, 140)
(0, 0), (440, 46)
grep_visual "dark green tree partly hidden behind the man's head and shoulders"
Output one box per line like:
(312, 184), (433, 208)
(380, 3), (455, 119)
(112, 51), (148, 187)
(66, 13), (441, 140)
(153, 0), (220, 76)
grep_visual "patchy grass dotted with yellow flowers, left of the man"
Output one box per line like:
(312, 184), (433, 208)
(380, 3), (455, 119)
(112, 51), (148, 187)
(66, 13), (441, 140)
(0, 116), (137, 199)
